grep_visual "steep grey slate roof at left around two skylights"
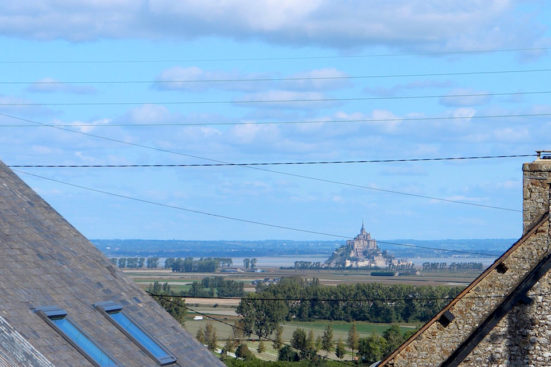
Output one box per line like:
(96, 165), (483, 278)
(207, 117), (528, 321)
(0, 162), (222, 367)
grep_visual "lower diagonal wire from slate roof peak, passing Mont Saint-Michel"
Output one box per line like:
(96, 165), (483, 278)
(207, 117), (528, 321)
(15, 170), (504, 257)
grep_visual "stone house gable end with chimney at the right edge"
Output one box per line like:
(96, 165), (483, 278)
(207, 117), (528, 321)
(379, 152), (551, 367)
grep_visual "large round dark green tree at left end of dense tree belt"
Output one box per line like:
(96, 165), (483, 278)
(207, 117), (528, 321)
(236, 294), (289, 339)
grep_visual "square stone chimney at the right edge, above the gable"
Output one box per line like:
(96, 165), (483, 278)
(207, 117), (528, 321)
(522, 150), (551, 234)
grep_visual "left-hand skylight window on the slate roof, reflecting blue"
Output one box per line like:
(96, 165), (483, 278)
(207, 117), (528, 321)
(36, 307), (119, 367)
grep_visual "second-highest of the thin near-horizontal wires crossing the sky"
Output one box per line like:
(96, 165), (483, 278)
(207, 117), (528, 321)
(5, 69), (551, 85)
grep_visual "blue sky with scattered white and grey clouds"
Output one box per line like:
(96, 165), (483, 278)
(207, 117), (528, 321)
(0, 0), (551, 240)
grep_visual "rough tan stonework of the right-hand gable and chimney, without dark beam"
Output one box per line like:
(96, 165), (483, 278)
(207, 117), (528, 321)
(381, 160), (551, 367)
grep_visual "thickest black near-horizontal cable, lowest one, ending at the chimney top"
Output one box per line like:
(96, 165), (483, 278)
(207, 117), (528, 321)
(8, 154), (537, 168)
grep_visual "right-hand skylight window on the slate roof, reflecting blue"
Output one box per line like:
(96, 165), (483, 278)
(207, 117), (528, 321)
(94, 302), (176, 366)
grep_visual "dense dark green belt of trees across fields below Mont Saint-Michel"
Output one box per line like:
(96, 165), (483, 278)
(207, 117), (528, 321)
(237, 278), (462, 330)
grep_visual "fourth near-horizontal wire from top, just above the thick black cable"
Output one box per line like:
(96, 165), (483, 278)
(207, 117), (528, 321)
(0, 113), (551, 128)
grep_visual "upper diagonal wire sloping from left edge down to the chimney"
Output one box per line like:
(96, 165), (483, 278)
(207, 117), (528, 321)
(0, 112), (520, 212)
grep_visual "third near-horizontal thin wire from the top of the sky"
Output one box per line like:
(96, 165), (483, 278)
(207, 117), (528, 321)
(0, 91), (551, 107)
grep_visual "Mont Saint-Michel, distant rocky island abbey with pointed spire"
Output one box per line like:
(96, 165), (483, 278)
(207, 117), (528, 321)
(325, 223), (411, 268)
